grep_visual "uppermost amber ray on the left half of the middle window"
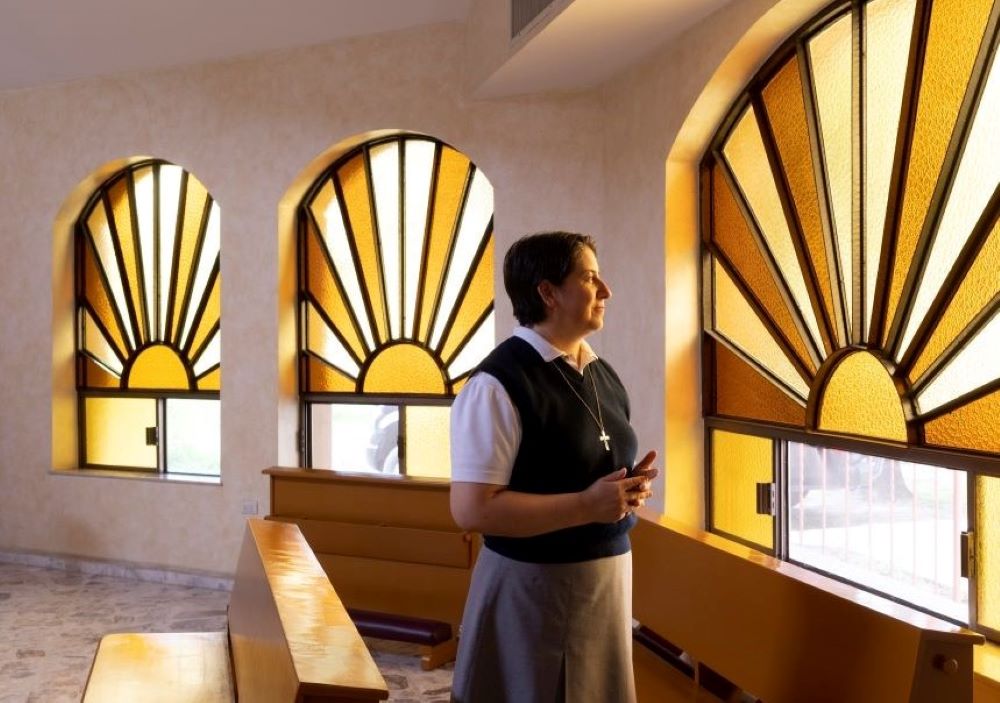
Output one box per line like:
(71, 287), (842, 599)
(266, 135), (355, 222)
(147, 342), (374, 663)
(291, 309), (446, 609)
(337, 154), (388, 348)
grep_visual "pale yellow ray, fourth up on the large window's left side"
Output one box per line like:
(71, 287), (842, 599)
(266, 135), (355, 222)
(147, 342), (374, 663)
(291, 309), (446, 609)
(724, 106), (823, 349)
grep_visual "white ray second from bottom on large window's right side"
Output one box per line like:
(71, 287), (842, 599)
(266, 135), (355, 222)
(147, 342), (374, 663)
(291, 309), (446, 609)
(917, 312), (1000, 414)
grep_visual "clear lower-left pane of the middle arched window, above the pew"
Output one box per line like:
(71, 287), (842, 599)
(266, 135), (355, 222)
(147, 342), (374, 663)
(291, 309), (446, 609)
(311, 404), (399, 474)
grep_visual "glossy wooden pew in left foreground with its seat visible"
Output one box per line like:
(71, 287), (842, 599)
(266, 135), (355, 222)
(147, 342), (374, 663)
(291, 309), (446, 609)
(83, 520), (389, 703)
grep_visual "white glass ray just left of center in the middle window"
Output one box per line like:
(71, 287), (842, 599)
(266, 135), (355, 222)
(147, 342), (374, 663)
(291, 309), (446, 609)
(371, 142), (401, 339)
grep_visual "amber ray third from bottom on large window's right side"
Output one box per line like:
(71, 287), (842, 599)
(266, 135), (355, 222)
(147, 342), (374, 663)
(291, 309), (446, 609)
(909, 222), (1000, 383)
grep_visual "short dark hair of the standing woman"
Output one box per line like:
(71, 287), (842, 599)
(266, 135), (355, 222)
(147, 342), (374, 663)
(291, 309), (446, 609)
(503, 232), (597, 327)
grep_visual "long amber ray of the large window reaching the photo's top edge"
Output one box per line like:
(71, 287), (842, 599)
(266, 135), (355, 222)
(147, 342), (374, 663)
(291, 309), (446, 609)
(884, 0), (993, 346)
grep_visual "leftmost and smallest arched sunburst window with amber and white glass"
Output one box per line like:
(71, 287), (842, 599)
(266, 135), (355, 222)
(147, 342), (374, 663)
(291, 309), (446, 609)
(76, 160), (221, 475)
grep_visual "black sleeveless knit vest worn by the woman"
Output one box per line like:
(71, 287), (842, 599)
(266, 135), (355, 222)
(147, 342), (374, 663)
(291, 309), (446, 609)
(477, 337), (637, 563)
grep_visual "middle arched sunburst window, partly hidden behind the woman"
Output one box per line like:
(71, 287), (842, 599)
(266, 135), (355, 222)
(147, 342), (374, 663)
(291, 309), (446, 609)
(299, 135), (494, 476)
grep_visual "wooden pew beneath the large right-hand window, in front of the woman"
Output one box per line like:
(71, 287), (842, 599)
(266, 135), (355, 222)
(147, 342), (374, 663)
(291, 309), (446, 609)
(632, 514), (984, 703)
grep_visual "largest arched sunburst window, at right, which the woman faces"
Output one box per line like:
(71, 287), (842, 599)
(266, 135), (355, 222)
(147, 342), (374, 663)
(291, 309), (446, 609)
(702, 0), (1000, 630)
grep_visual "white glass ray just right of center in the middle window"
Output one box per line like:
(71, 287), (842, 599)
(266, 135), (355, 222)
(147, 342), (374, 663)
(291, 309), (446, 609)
(403, 139), (434, 336)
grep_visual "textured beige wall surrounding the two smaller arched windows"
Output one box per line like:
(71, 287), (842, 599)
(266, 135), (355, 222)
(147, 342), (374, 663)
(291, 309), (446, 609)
(0, 25), (603, 572)
